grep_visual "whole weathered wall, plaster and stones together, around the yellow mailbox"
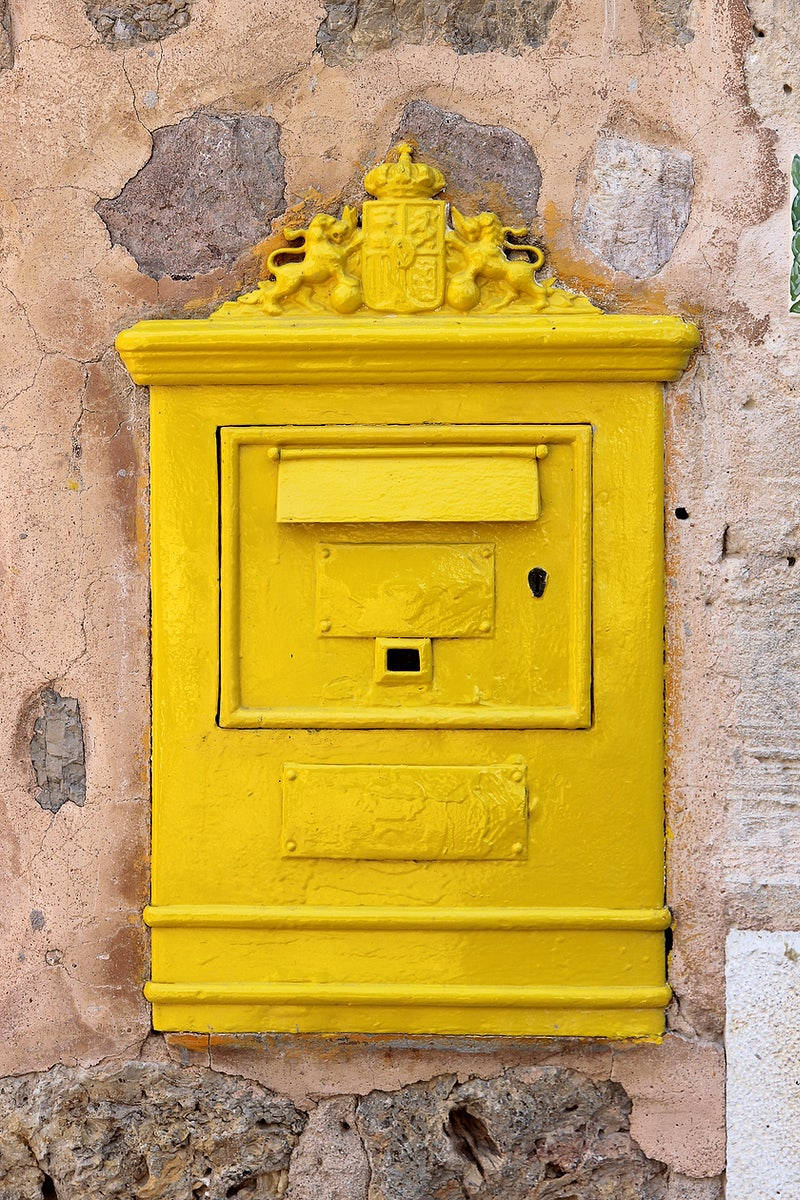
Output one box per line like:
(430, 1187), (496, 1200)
(0, 0), (800, 1200)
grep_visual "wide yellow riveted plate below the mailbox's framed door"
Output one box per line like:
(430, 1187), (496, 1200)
(282, 762), (528, 862)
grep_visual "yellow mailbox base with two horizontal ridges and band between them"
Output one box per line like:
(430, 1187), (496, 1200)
(145, 905), (670, 1037)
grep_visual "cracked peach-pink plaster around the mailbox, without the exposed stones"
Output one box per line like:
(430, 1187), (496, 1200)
(0, 0), (800, 1185)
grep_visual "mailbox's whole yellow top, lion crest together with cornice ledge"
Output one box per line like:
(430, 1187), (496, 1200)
(116, 143), (699, 384)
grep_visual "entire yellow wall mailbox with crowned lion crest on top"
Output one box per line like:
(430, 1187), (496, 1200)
(118, 145), (697, 1037)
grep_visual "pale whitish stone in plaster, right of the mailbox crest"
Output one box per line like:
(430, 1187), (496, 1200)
(579, 137), (694, 280)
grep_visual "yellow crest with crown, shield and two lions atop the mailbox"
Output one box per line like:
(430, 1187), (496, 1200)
(213, 143), (597, 319)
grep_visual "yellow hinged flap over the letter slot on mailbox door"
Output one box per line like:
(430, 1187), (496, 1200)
(277, 445), (540, 524)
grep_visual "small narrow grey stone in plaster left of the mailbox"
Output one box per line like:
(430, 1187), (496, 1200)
(30, 688), (86, 812)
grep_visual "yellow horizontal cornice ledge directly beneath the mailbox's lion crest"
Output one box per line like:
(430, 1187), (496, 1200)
(116, 312), (699, 386)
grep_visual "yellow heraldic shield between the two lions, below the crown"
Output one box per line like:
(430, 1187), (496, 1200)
(362, 200), (445, 312)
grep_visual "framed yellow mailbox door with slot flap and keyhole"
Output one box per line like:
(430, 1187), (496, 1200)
(219, 425), (591, 728)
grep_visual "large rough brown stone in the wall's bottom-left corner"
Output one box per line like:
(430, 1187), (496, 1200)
(0, 1063), (305, 1200)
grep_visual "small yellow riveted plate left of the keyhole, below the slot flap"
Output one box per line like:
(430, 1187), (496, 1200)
(317, 542), (494, 637)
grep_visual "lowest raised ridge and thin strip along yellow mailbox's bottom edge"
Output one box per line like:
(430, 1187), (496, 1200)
(145, 982), (672, 1038)
